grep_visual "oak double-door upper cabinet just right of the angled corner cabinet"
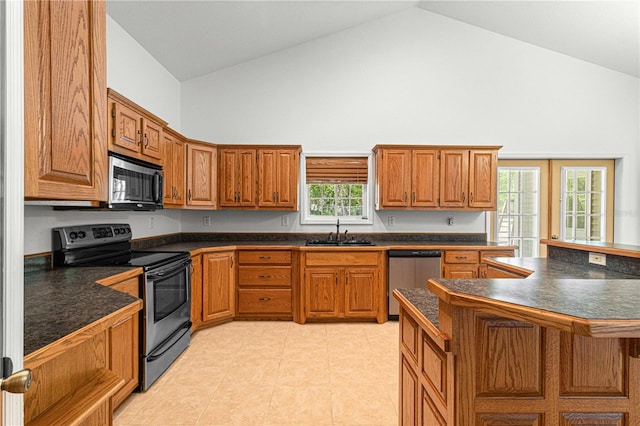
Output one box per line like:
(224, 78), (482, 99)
(218, 148), (257, 207)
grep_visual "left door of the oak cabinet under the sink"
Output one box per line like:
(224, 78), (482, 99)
(304, 268), (340, 318)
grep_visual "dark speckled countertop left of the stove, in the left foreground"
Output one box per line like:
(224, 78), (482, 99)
(24, 267), (138, 355)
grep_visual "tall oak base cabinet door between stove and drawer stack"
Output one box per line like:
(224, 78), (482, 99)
(202, 252), (235, 322)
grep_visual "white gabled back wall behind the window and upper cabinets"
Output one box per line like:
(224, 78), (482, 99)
(181, 8), (640, 244)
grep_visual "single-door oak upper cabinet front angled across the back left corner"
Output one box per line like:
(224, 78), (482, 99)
(186, 143), (216, 208)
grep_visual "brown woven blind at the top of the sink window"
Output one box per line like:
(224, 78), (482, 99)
(306, 157), (369, 184)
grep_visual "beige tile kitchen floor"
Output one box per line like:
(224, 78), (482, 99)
(114, 321), (398, 426)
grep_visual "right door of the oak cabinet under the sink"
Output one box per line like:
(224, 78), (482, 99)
(344, 268), (379, 318)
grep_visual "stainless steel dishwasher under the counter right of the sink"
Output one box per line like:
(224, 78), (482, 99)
(387, 250), (442, 320)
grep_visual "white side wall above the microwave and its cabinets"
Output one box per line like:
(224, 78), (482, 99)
(107, 15), (180, 132)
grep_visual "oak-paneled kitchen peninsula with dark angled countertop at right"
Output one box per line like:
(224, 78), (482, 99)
(394, 240), (640, 426)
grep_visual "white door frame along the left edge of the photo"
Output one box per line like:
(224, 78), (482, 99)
(0, 0), (24, 425)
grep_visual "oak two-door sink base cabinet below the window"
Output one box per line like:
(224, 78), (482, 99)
(298, 249), (387, 324)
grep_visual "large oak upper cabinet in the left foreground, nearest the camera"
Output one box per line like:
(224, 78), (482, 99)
(24, 0), (107, 203)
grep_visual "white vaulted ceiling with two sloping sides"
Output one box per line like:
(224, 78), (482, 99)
(107, 0), (640, 81)
